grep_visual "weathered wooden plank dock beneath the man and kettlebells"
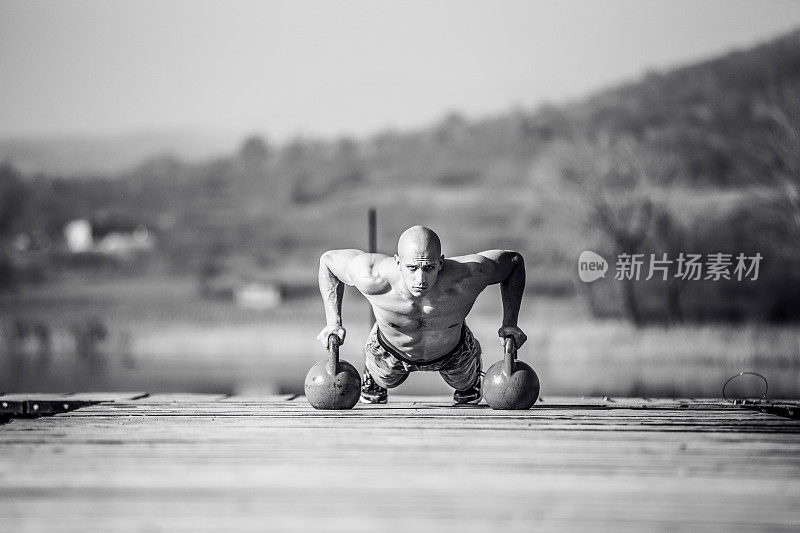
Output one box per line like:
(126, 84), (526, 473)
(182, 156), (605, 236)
(0, 393), (800, 532)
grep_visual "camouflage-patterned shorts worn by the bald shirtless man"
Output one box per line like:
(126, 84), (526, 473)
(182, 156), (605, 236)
(364, 324), (481, 390)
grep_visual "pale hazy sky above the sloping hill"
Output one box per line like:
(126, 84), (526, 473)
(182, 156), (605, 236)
(0, 0), (800, 140)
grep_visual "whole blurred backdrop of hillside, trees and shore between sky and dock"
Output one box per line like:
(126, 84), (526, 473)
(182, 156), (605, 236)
(0, 28), (800, 396)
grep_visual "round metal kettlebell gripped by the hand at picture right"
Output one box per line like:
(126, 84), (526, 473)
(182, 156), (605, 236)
(483, 337), (539, 410)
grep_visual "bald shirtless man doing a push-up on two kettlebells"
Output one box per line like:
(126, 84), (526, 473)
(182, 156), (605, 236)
(317, 226), (527, 404)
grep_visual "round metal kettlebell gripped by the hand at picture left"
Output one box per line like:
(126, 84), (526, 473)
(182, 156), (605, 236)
(304, 333), (361, 409)
